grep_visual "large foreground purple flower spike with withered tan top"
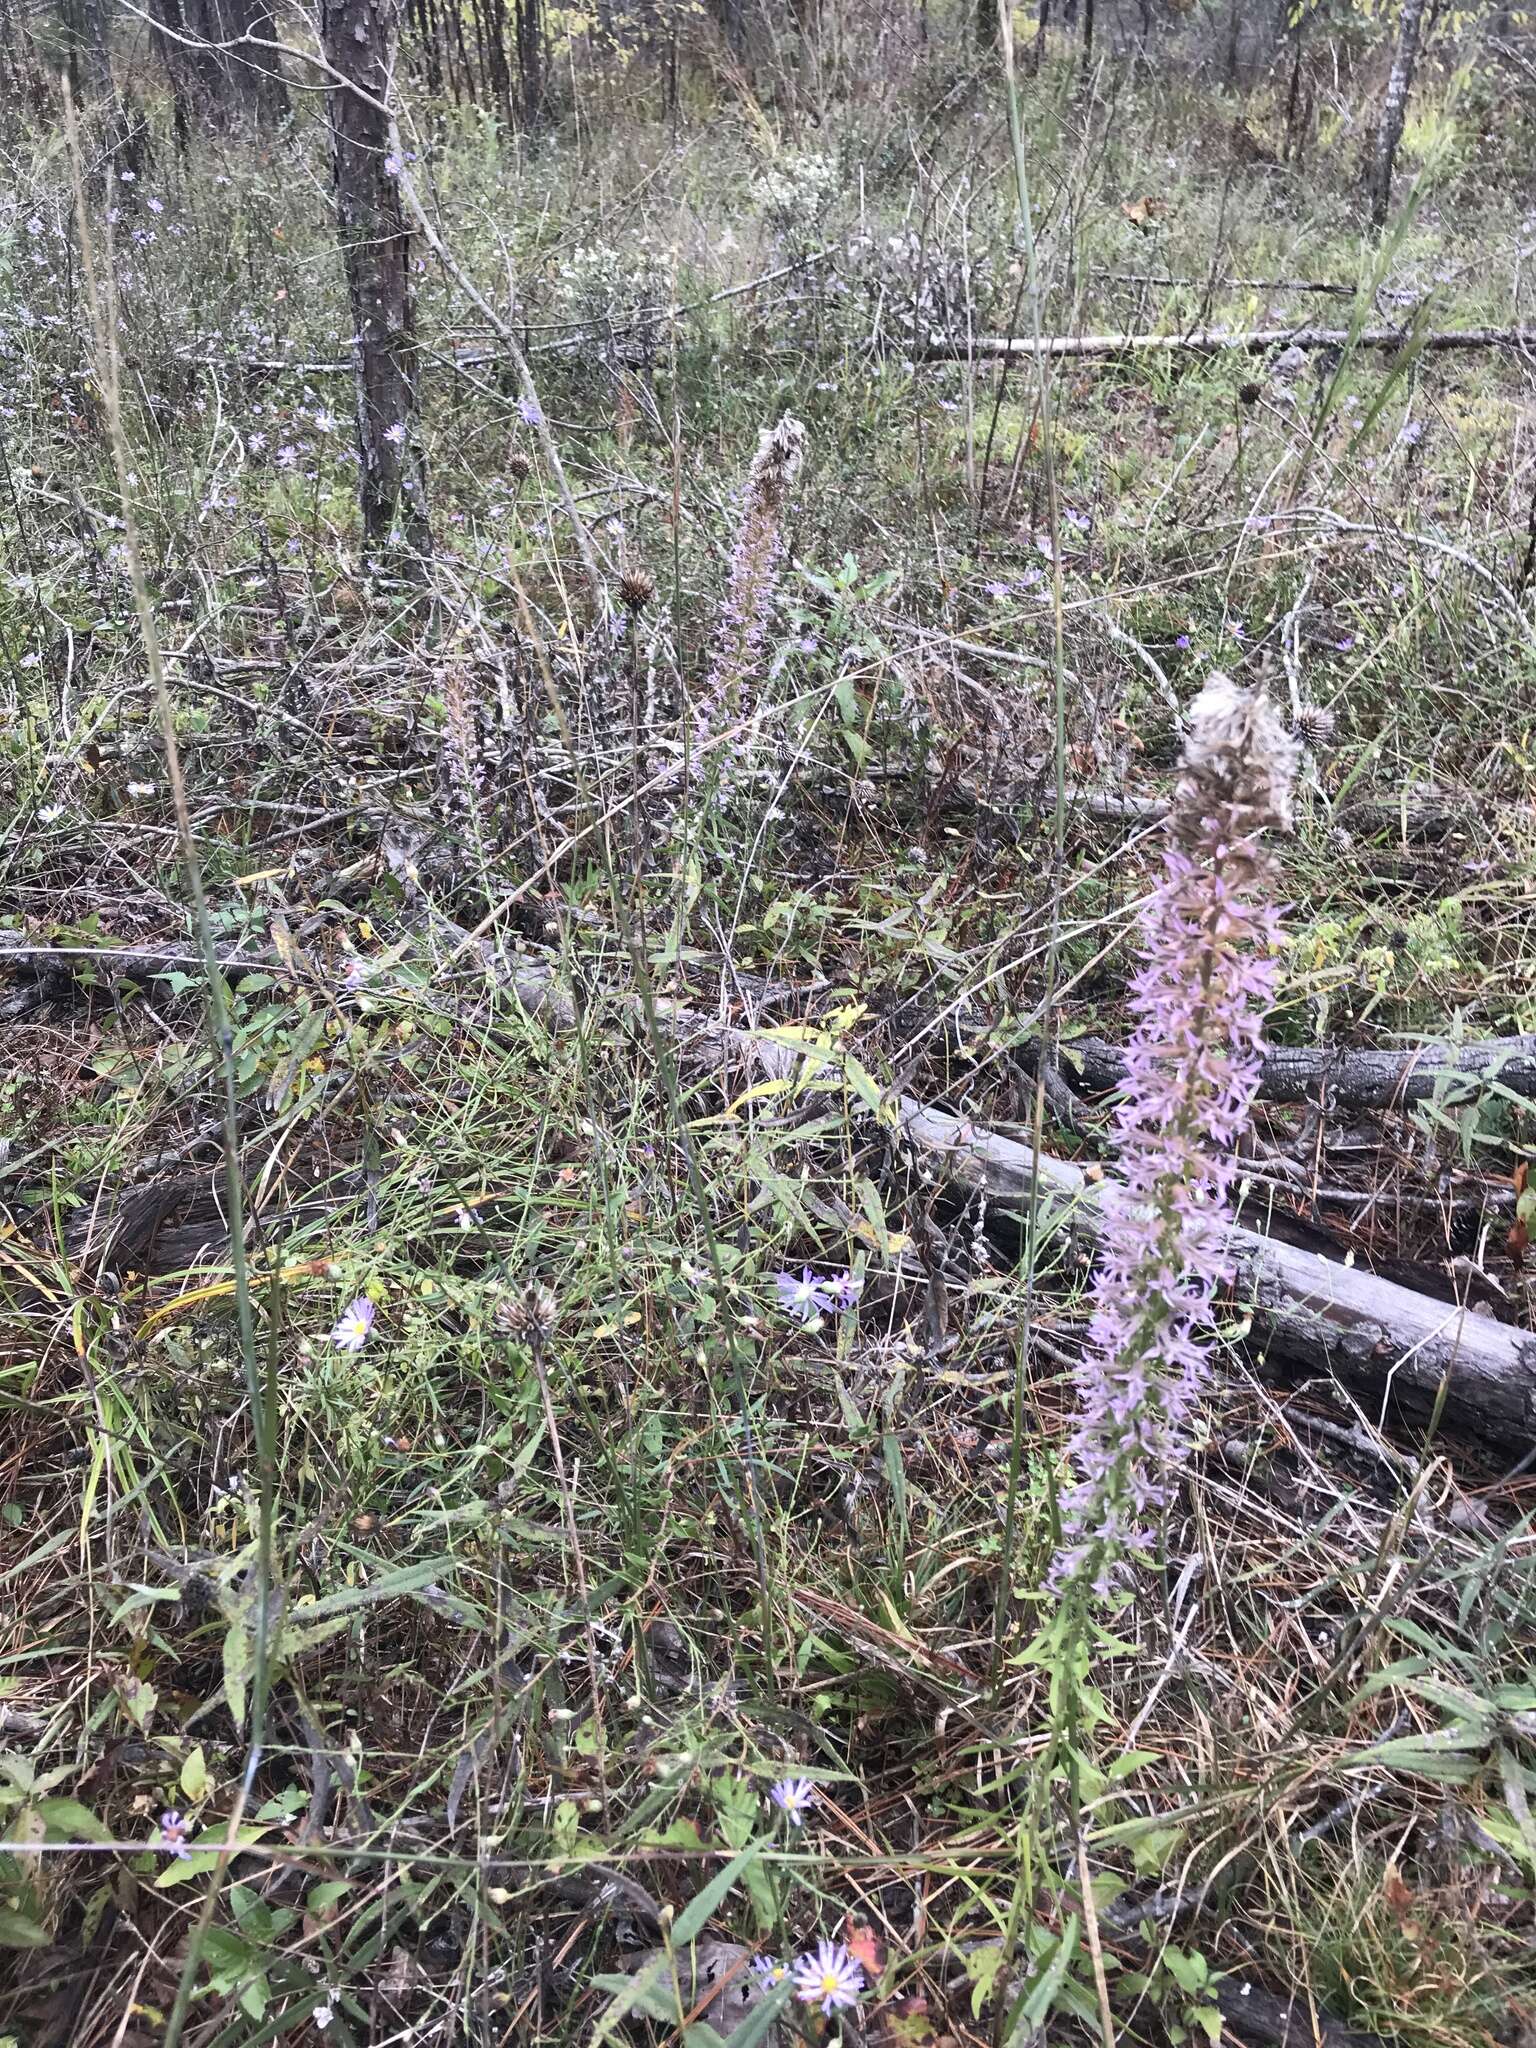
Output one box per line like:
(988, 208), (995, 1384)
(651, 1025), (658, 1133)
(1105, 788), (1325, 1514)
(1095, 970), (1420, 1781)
(1053, 676), (1296, 1599)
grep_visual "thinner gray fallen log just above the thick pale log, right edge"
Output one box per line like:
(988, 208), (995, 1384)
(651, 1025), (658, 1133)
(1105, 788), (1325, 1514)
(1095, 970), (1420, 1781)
(1059, 1032), (1536, 1110)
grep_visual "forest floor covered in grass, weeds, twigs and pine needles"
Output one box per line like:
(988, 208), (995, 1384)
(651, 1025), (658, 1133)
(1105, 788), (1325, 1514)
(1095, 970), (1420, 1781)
(0, 28), (1536, 2048)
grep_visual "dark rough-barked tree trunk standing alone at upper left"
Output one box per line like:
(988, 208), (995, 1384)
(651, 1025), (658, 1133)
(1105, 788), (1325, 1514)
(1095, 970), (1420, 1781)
(319, 0), (426, 547)
